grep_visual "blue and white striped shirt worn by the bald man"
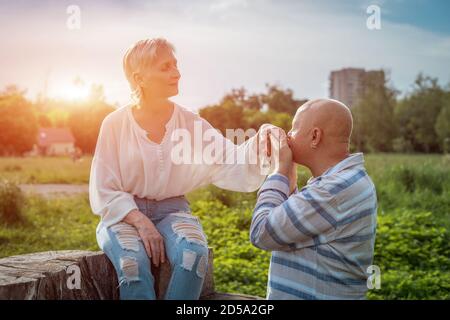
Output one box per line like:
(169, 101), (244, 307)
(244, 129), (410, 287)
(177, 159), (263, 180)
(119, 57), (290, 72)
(250, 153), (377, 299)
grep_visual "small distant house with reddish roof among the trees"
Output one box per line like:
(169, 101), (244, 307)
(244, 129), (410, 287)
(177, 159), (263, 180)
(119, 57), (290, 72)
(30, 128), (76, 156)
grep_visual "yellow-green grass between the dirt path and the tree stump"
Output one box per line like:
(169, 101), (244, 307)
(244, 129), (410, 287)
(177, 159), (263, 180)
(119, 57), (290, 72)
(0, 195), (99, 257)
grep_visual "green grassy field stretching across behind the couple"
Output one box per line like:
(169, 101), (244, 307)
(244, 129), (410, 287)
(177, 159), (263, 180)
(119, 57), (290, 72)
(0, 154), (450, 299)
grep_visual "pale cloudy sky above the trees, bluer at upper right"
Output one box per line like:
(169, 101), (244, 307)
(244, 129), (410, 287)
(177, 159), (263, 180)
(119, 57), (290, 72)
(0, 0), (450, 110)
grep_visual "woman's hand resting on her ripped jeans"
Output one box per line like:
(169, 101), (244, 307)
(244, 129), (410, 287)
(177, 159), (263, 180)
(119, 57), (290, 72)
(123, 210), (166, 267)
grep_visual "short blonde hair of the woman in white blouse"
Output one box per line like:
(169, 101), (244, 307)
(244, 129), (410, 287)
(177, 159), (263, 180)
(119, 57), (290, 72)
(123, 38), (175, 100)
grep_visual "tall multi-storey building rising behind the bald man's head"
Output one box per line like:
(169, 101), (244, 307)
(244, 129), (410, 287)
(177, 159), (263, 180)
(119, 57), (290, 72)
(330, 68), (385, 108)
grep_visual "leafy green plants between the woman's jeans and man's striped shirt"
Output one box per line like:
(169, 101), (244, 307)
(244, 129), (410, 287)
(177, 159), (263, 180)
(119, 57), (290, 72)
(192, 200), (270, 297)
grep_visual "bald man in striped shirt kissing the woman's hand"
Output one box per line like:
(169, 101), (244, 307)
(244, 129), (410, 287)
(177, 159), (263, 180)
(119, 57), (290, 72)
(250, 99), (377, 300)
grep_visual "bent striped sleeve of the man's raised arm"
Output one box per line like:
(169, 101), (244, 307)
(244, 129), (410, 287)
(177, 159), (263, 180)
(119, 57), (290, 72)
(250, 174), (337, 251)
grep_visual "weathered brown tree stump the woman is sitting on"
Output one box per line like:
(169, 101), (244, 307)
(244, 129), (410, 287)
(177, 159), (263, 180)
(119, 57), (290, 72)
(0, 249), (215, 300)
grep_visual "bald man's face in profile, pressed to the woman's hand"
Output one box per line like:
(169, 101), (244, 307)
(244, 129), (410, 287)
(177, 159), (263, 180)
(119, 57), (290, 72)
(287, 106), (311, 165)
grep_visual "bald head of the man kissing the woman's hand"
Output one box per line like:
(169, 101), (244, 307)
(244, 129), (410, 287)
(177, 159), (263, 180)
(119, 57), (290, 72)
(288, 99), (353, 163)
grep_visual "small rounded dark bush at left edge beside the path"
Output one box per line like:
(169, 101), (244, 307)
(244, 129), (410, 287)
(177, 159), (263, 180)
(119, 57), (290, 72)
(0, 180), (25, 224)
